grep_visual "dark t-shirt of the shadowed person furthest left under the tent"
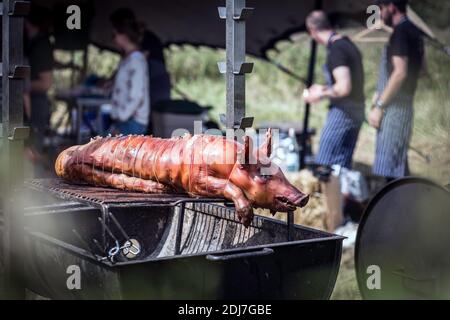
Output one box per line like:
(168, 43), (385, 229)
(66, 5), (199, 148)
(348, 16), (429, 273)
(26, 34), (54, 81)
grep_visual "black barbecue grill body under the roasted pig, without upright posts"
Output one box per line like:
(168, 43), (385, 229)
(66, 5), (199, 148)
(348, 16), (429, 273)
(21, 179), (343, 299)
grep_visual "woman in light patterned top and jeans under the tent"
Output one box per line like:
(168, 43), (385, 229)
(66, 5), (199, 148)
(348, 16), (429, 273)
(110, 15), (150, 135)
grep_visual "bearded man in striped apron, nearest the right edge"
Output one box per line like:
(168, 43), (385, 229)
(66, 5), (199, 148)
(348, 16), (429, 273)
(369, 0), (424, 181)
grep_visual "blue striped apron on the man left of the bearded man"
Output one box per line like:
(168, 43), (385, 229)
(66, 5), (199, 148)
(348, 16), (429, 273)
(315, 66), (364, 169)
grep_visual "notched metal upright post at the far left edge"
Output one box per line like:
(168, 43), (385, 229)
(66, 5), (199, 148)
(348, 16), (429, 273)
(0, 0), (30, 298)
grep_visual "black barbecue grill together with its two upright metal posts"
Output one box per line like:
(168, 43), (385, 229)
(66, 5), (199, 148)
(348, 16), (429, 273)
(2, 0), (343, 299)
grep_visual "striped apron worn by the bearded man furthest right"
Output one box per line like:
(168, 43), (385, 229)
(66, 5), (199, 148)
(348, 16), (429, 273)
(373, 45), (414, 178)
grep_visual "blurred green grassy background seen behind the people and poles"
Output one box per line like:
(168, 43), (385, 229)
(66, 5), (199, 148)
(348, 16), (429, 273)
(51, 0), (450, 182)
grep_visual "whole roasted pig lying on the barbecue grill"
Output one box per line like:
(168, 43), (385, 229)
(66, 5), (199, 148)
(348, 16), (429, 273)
(55, 130), (309, 226)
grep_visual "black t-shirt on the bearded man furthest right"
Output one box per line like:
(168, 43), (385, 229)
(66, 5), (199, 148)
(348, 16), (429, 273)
(387, 19), (424, 96)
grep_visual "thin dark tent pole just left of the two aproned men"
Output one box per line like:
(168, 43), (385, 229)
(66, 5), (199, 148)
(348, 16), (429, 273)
(300, 0), (322, 169)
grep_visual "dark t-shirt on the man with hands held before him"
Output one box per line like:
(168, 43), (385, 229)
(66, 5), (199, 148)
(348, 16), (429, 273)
(326, 37), (365, 106)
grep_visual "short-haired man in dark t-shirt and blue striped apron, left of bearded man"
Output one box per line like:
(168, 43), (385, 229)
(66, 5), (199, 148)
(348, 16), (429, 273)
(304, 11), (365, 231)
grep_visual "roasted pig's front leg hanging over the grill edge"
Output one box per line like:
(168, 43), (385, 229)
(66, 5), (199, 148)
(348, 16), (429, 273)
(199, 176), (253, 227)
